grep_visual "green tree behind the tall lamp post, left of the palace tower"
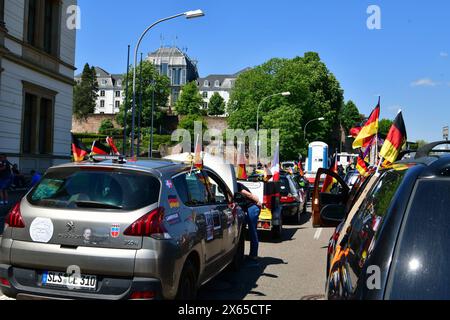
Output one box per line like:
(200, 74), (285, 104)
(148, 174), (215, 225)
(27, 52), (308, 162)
(116, 61), (170, 134)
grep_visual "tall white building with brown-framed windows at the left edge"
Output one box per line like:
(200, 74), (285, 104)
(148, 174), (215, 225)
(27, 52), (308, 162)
(0, 0), (77, 173)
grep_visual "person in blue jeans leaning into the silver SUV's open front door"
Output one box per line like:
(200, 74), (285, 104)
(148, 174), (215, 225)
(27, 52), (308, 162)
(238, 183), (262, 266)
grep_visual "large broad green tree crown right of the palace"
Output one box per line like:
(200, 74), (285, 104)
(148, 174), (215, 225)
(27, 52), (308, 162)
(229, 52), (344, 159)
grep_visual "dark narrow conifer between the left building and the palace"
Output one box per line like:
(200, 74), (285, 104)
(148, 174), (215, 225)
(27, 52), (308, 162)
(73, 63), (98, 120)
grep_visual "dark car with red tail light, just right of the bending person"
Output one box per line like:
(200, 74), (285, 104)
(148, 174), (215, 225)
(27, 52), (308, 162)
(280, 173), (306, 224)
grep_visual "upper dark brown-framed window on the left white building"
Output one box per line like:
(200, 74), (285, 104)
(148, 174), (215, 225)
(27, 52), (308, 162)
(24, 0), (61, 55)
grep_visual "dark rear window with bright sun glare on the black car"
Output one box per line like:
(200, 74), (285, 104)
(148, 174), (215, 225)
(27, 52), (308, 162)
(387, 178), (450, 300)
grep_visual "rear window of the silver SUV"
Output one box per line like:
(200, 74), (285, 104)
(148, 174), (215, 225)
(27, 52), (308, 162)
(27, 168), (161, 211)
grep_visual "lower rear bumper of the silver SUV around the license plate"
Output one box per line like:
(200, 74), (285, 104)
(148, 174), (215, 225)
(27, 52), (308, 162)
(0, 265), (162, 300)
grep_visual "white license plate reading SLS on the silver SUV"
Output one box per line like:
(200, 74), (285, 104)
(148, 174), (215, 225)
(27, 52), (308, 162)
(42, 271), (97, 290)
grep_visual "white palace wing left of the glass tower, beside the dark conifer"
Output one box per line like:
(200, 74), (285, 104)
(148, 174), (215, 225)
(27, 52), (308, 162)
(75, 67), (125, 114)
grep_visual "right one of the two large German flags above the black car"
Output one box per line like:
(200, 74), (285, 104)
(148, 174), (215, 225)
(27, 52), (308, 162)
(380, 111), (408, 163)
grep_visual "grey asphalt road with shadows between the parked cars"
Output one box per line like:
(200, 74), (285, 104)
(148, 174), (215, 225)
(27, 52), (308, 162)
(0, 205), (332, 300)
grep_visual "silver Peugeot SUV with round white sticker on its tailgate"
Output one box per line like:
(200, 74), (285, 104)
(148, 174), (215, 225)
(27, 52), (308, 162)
(0, 160), (245, 300)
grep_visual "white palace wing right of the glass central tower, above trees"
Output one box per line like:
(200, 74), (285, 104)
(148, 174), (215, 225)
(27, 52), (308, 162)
(197, 69), (248, 115)
